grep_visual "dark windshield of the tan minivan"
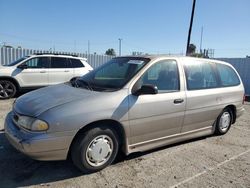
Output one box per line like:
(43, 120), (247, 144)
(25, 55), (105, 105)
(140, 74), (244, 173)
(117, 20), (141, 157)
(75, 57), (150, 91)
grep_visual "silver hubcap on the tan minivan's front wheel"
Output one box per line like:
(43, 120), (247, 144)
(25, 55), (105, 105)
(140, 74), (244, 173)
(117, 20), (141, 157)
(86, 135), (113, 167)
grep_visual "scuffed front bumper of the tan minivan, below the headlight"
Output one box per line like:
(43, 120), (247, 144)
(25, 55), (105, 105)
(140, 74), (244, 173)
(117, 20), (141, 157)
(4, 112), (75, 161)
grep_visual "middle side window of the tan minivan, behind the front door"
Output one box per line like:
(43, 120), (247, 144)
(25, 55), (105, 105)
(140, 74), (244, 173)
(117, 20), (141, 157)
(184, 62), (219, 90)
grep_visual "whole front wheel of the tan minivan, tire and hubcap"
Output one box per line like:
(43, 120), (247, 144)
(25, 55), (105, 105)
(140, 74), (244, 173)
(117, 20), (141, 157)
(70, 126), (119, 174)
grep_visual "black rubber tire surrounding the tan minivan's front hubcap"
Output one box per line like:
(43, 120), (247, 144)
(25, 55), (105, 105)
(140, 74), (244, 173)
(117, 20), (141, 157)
(70, 126), (119, 174)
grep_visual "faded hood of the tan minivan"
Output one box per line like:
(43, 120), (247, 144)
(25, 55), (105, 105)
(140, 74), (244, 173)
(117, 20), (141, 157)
(14, 84), (98, 117)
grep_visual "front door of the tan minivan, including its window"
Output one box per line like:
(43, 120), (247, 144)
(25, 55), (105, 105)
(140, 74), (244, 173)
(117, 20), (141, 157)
(129, 60), (186, 145)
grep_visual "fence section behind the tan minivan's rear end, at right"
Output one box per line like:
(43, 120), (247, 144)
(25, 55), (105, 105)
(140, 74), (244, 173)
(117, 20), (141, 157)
(218, 58), (250, 96)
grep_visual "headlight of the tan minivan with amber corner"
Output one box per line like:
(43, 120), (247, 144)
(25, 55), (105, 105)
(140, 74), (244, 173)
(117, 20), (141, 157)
(17, 116), (49, 131)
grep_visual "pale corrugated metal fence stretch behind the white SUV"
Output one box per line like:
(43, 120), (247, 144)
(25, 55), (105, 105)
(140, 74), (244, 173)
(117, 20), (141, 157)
(0, 47), (113, 68)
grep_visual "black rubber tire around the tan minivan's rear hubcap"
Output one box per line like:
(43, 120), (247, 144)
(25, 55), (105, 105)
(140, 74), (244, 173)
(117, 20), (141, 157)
(215, 108), (233, 135)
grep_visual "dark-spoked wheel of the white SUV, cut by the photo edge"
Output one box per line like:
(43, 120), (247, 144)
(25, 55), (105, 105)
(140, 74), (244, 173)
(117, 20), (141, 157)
(0, 80), (17, 100)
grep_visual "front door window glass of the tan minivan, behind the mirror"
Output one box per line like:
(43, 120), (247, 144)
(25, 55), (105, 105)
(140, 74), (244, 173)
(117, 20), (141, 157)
(139, 60), (179, 93)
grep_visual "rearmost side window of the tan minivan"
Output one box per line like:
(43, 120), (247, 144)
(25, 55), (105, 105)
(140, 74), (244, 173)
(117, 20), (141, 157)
(216, 64), (240, 86)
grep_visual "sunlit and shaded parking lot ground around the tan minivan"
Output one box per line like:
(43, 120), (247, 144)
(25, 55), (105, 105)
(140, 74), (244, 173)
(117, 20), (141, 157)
(0, 99), (250, 188)
